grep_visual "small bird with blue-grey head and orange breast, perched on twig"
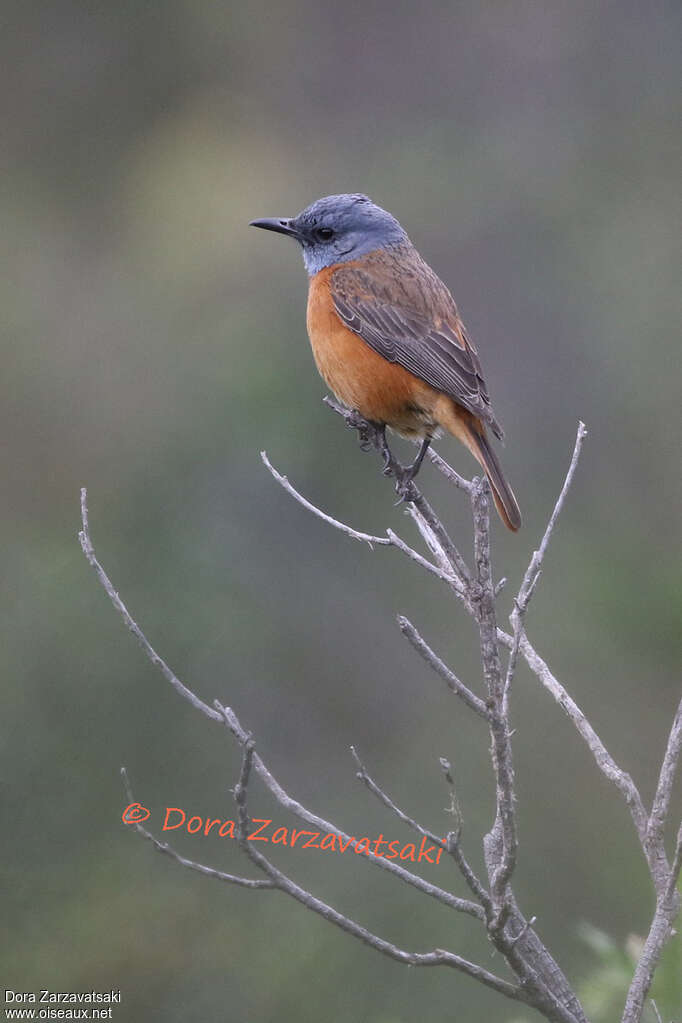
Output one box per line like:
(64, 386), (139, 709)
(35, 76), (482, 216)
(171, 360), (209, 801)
(249, 193), (521, 532)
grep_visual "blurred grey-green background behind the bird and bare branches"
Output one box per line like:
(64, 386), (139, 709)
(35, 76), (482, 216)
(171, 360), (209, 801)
(0, 0), (682, 1023)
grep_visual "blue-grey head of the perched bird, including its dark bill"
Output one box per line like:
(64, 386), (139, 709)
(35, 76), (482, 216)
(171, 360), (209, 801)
(251, 194), (409, 277)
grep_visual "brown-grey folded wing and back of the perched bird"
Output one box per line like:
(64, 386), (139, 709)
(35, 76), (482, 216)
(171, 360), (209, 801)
(330, 247), (502, 438)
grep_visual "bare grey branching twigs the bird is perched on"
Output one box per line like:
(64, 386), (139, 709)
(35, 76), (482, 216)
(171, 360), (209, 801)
(79, 399), (682, 1023)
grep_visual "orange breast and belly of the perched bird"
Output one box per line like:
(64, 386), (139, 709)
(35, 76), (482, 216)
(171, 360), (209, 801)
(308, 267), (439, 436)
